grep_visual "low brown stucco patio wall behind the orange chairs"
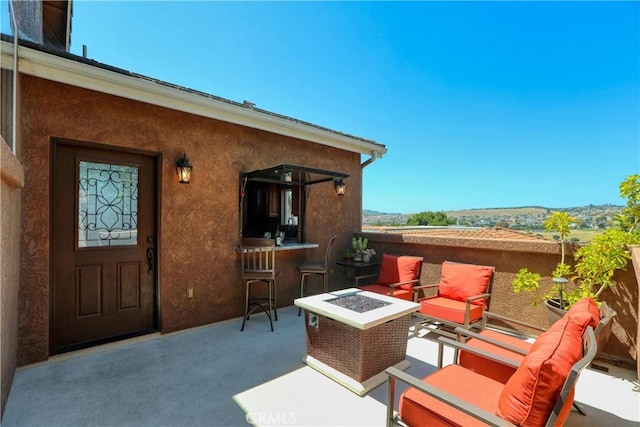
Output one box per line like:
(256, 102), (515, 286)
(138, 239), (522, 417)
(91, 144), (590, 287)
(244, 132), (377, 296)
(355, 233), (640, 361)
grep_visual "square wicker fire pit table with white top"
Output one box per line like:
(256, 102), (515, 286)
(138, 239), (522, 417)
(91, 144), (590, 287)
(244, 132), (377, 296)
(294, 288), (420, 395)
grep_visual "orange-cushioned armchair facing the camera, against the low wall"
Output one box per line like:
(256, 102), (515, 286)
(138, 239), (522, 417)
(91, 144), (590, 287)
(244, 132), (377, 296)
(414, 261), (495, 335)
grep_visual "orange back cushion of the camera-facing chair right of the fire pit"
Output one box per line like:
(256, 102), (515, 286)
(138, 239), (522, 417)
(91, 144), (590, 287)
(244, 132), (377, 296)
(438, 261), (493, 309)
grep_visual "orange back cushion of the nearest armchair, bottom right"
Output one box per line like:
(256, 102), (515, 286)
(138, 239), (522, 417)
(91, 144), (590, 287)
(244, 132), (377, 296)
(497, 298), (599, 425)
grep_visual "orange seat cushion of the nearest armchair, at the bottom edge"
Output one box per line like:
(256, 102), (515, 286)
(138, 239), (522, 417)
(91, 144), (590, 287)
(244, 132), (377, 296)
(398, 365), (504, 427)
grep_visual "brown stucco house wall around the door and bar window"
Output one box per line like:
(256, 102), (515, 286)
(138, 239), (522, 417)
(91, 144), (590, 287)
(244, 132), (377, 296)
(18, 76), (362, 365)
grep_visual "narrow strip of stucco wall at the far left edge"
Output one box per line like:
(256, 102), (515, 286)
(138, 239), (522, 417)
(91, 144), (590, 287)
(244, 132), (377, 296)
(0, 139), (24, 417)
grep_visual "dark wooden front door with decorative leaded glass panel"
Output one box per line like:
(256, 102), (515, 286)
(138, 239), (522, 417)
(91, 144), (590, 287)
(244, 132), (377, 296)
(50, 141), (158, 354)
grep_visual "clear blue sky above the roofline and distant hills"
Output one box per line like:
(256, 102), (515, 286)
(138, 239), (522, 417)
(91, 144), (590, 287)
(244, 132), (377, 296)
(3, 0), (640, 213)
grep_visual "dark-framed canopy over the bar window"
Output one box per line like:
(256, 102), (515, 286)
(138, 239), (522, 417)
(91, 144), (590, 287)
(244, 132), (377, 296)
(242, 164), (349, 185)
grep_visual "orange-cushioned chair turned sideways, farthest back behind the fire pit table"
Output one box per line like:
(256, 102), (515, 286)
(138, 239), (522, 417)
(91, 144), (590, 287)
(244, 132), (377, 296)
(356, 254), (423, 301)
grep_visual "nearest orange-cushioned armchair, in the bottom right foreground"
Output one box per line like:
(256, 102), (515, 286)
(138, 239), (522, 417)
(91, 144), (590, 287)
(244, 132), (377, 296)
(386, 300), (597, 427)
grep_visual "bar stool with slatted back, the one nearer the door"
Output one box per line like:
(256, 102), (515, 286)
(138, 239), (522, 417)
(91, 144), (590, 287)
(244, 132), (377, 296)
(240, 238), (278, 332)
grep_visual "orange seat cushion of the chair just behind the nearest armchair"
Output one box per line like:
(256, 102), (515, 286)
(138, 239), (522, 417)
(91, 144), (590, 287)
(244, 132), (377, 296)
(458, 329), (532, 384)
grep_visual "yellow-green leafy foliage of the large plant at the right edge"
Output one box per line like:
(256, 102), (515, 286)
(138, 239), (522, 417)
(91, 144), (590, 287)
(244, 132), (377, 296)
(512, 175), (640, 322)
